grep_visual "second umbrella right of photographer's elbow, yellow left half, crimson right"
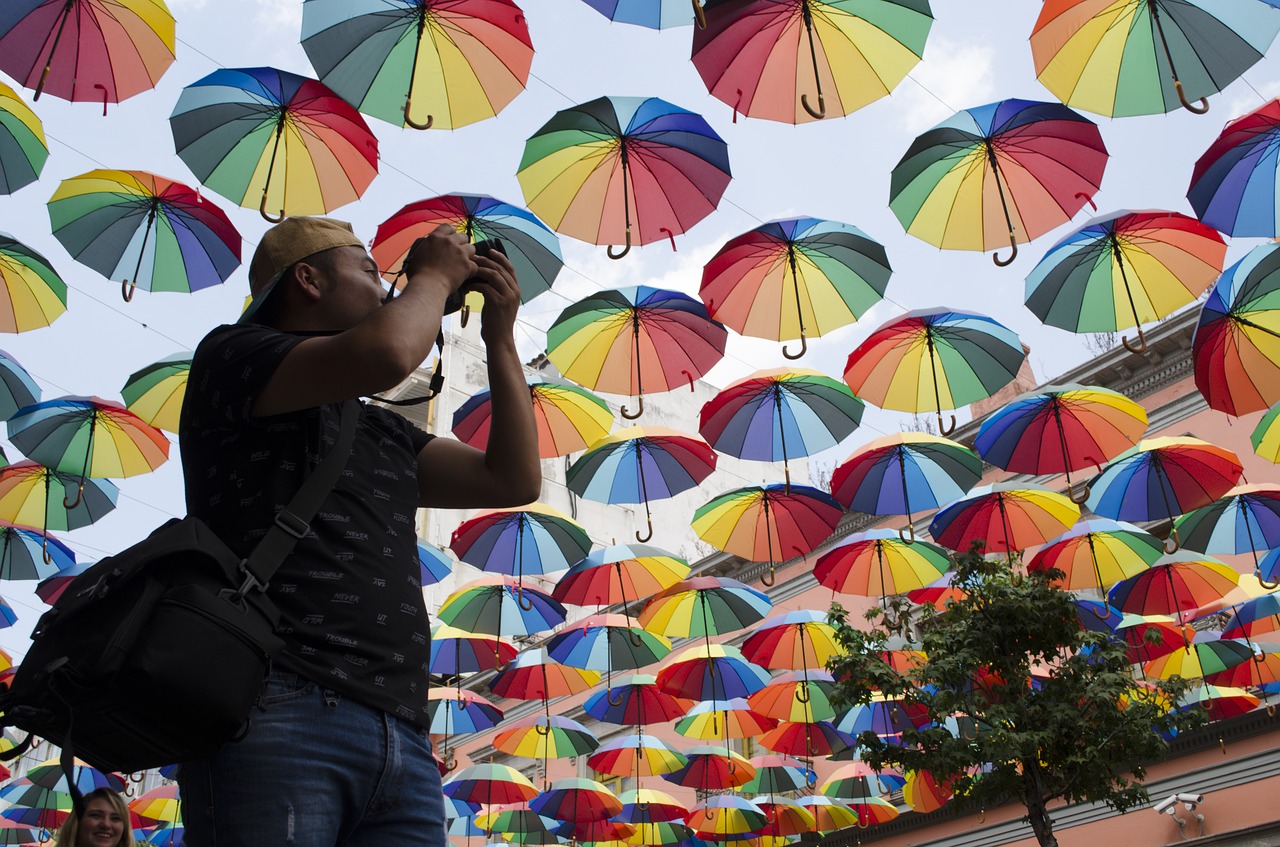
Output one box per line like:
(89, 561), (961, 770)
(692, 484), (845, 586)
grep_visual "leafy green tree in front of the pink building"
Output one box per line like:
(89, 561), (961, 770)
(828, 546), (1204, 847)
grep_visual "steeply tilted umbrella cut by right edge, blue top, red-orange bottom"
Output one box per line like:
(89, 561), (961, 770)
(1192, 242), (1280, 416)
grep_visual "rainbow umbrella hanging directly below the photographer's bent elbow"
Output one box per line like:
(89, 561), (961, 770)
(449, 503), (591, 603)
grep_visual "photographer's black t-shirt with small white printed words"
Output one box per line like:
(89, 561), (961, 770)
(178, 324), (431, 725)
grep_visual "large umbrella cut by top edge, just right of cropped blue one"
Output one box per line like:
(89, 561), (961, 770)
(692, 0), (933, 124)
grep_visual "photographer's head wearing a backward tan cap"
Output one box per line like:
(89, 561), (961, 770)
(241, 218), (383, 330)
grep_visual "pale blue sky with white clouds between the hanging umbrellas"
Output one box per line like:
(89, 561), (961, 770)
(0, 0), (1280, 660)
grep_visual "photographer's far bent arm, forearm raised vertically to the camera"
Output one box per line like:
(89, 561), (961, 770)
(417, 253), (543, 509)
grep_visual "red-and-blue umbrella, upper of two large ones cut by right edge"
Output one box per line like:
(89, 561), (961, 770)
(1187, 100), (1280, 238)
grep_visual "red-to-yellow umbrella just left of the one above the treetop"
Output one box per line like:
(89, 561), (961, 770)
(813, 530), (951, 598)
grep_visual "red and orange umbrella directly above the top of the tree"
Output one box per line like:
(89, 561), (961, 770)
(929, 482), (1080, 562)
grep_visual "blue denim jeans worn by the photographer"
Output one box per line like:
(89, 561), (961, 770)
(178, 670), (445, 847)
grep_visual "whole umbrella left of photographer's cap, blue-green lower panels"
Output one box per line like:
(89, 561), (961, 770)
(49, 169), (241, 301)
